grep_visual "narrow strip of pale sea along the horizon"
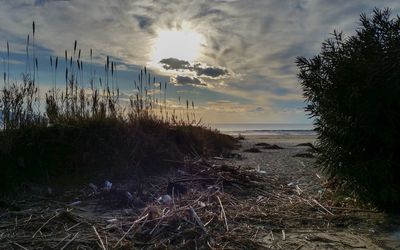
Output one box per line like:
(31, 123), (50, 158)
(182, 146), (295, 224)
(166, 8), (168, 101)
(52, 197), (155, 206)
(210, 123), (316, 136)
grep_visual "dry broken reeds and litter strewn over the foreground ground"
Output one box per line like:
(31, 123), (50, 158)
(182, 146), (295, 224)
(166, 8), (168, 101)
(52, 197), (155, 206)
(0, 155), (372, 249)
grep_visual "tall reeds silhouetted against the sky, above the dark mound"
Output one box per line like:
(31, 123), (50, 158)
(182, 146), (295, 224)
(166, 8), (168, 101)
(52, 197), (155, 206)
(0, 25), (198, 130)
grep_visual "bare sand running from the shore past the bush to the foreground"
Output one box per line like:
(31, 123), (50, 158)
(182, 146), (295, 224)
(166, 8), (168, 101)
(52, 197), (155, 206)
(227, 135), (400, 249)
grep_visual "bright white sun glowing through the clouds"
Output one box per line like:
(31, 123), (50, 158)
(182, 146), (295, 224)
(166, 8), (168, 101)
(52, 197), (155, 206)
(151, 27), (204, 65)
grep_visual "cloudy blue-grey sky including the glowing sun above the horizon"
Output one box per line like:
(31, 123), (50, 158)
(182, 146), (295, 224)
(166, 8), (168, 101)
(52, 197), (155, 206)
(0, 0), (400, 123)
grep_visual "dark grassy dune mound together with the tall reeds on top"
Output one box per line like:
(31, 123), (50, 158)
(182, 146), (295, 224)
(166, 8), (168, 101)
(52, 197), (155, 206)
(0, 23), (235, 190)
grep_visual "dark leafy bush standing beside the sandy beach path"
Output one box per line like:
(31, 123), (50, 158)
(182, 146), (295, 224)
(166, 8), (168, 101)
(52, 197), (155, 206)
(296, 9), (400, 209)
